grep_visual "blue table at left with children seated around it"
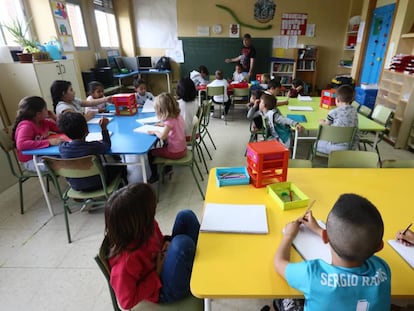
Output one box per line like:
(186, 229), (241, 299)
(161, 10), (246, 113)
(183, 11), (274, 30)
(23, 112), (157, 216)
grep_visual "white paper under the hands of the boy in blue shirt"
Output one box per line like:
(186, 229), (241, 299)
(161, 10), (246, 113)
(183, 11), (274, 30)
(293, 220), (332, 263)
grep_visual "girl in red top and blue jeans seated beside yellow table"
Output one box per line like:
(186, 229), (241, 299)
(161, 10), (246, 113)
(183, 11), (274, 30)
(105, 183), (200, 310)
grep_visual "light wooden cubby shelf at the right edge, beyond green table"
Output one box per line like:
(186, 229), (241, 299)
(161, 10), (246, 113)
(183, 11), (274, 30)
(375, 70), (414, 148)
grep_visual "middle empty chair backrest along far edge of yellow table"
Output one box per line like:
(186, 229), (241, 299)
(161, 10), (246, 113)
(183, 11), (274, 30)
(328, 150), (379, 168)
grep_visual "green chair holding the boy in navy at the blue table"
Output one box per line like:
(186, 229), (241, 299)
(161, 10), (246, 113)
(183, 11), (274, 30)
(42, 155), (123, 243)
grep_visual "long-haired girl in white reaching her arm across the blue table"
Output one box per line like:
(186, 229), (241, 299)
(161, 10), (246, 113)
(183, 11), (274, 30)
(50, 80), (111, 121)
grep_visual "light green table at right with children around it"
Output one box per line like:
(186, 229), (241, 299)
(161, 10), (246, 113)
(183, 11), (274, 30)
(278, 97), (385, 159)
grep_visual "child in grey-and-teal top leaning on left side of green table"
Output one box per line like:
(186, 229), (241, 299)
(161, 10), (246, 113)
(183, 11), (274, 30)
(247, 93), (303, 148)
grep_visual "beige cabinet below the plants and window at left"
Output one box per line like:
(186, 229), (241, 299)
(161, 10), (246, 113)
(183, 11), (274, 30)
(0, 60), (83, 122)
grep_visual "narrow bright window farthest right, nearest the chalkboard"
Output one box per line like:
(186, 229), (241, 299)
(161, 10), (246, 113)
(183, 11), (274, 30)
(93, 0), (119, 47)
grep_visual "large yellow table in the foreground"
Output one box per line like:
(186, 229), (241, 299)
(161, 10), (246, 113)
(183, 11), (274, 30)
(191, 168), (414, 310)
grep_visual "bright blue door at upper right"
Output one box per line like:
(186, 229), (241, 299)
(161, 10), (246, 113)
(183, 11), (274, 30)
(360, 3), (395, 84)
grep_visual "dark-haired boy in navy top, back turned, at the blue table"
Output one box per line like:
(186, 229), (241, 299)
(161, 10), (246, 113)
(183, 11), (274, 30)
(58, 111), (128, 191)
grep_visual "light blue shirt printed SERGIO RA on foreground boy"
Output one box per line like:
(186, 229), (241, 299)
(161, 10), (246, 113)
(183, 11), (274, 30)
(285, 256), (391, 311)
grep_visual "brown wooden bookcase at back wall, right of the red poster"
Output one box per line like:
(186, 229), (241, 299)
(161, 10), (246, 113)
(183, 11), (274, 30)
(295, 47), (318, 95)
